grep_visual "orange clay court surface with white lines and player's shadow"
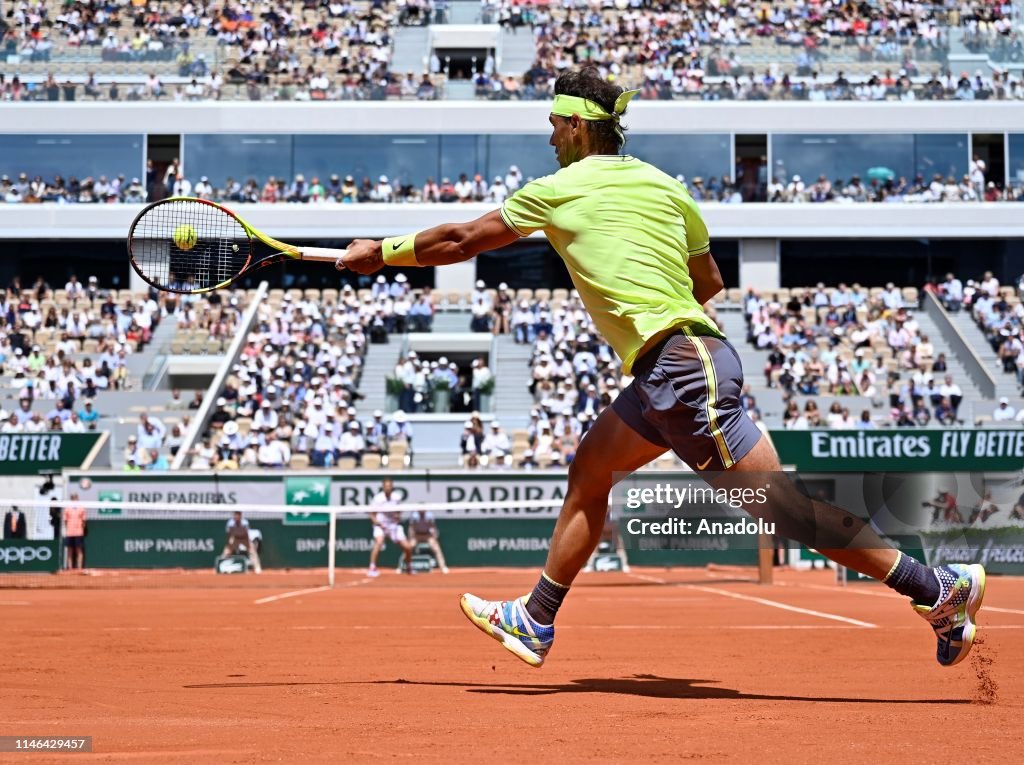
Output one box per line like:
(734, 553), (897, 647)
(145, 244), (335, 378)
(0, 569), (1024, 763)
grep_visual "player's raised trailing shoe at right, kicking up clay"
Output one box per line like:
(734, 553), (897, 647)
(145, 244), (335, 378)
(910, 563), (985, 667)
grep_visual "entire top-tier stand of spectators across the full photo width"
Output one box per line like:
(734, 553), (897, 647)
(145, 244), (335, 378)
(0, 0), (1024, 101)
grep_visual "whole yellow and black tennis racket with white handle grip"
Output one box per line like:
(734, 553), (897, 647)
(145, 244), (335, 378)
(128, 197), (346, 295)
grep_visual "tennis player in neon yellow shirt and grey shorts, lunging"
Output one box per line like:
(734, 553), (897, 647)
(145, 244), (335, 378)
(337, 69), (985, 667)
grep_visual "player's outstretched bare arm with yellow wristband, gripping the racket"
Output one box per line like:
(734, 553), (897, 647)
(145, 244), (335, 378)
(337, 210), (519, 273)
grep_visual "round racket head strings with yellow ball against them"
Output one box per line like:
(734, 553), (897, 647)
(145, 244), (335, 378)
(130, 200), (252, 292)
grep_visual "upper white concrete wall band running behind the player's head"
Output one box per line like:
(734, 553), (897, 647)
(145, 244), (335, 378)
(0, 101), (1022, 134)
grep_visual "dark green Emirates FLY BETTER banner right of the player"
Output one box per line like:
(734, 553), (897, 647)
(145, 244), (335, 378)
(771, 428), (1024, 473)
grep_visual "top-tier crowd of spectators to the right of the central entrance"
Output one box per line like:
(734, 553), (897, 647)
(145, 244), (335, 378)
(497, 0), (1021, 99)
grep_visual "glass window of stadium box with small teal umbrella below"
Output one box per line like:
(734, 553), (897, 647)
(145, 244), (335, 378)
(771, 133), (970, 184)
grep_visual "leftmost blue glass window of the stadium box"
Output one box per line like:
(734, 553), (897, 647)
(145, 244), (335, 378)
(0, 133), (145, 181)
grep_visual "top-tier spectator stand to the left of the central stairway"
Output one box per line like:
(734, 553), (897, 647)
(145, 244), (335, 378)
(0, 0), (443, 101)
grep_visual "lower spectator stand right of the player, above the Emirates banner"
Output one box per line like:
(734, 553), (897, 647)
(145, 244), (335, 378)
(733, 284), (1019, 429)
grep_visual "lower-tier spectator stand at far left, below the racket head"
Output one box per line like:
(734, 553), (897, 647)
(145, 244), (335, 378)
(0, 277), (216, 469)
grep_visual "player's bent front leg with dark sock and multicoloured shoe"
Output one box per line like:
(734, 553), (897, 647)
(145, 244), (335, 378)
(461, 403), (667, 667)
